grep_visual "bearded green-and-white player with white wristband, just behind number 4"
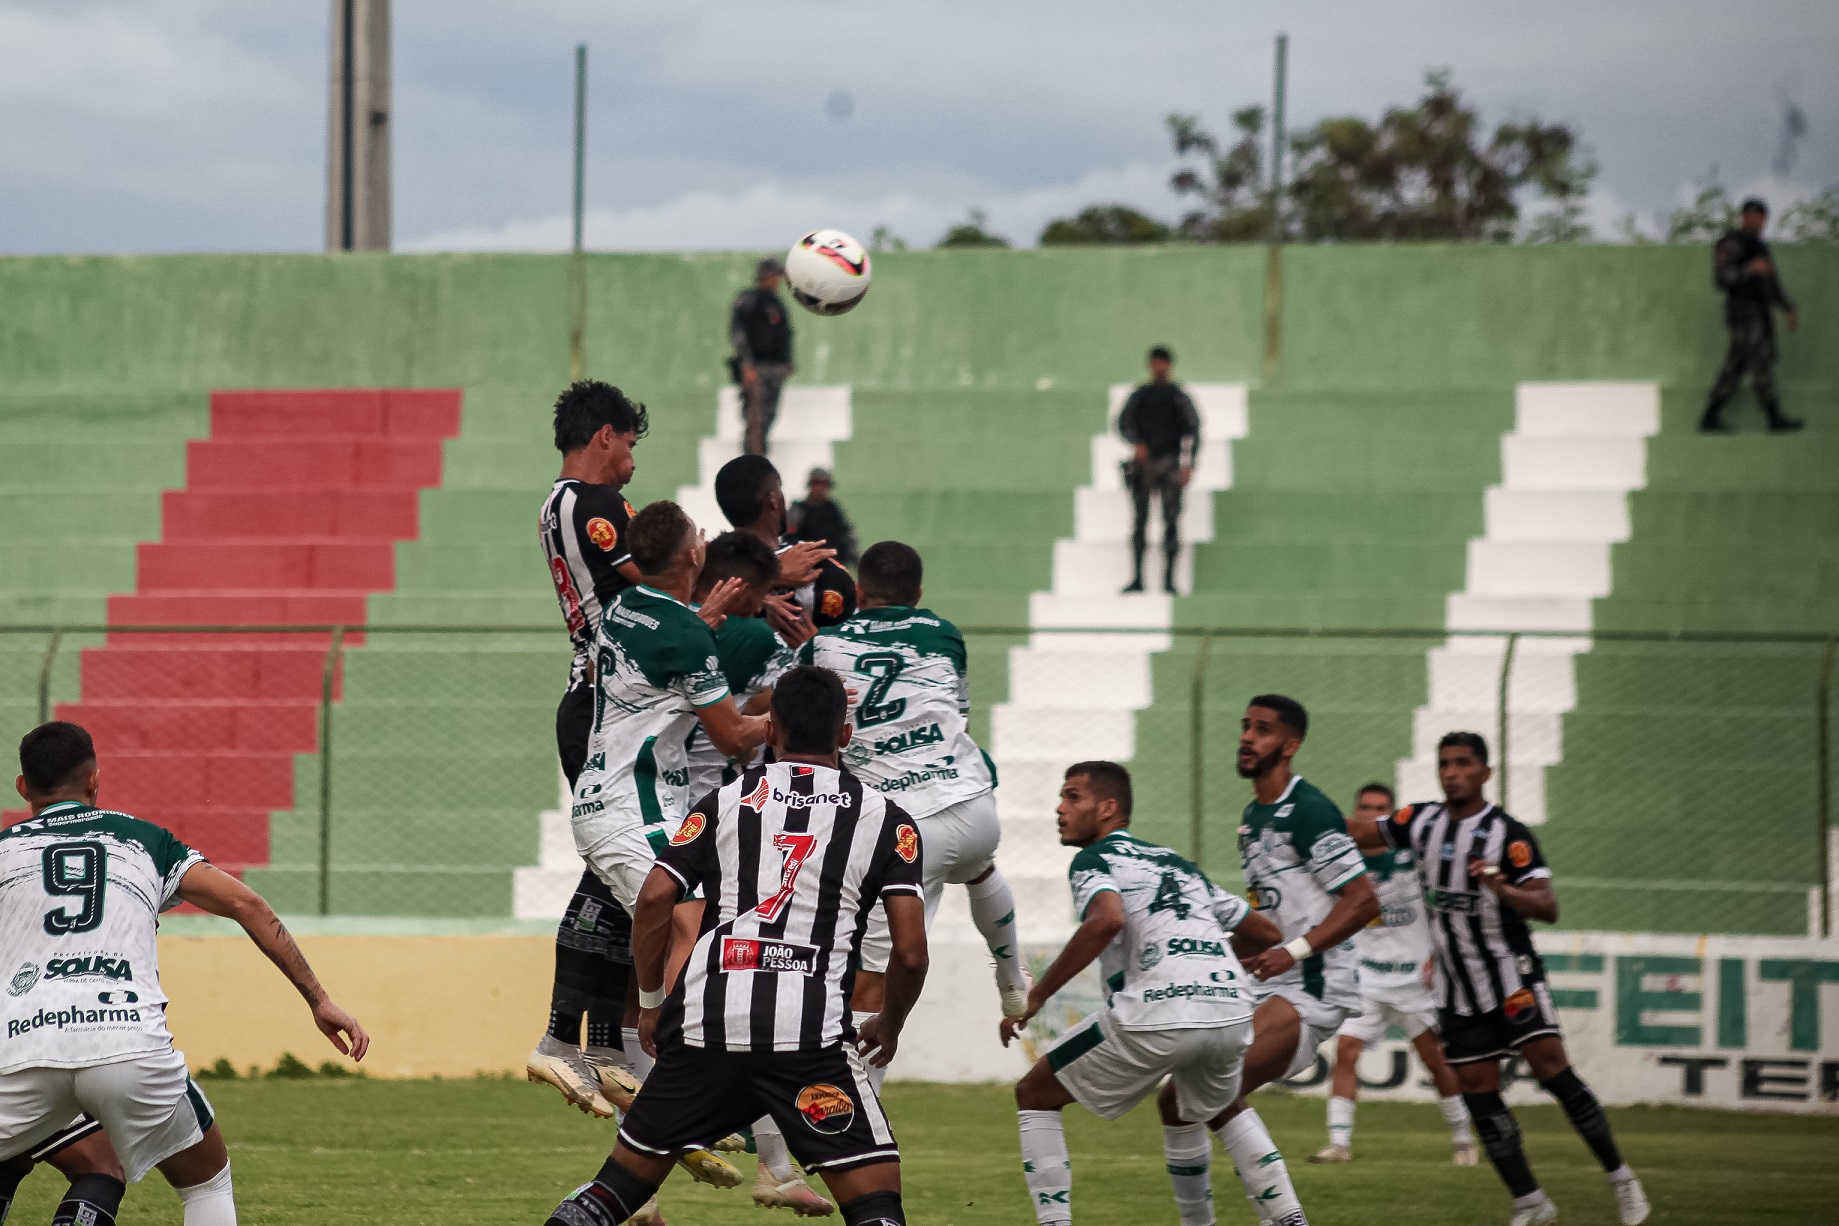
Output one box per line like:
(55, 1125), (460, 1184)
(1162, 695), (1379, 1222)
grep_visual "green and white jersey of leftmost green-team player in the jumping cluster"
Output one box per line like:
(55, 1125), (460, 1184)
(570, 585), (728, 855)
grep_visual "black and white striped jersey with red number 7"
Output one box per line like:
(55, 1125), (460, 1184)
(658, 763), (923, 1051)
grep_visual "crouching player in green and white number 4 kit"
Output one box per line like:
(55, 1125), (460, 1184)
(1002, 763), (1279, 1226)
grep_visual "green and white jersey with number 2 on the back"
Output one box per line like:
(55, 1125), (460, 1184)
(798, 607), (997, 818)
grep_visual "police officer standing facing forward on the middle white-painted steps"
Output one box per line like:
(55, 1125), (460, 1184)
(1118, 346), (1201, 594)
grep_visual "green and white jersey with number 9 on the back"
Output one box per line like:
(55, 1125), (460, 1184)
(0, 800), (204, 1073)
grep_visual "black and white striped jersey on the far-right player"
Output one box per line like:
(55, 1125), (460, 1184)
(1379, 801), (1552, 1016)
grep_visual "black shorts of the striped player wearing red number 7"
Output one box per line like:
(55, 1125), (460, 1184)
(620, 1042), (901, 1171)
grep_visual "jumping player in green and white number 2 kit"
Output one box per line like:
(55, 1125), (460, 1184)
(798, 540), (1028, 1016)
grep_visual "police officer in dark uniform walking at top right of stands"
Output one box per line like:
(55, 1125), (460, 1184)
(1699, 197), (1804, 434)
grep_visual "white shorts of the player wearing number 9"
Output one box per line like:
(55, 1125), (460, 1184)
(0, 1048), (211, 1184)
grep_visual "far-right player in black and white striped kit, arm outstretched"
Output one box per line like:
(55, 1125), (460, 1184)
(1348, 732), (1648, 1226)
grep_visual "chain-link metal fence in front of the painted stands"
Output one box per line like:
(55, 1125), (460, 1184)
(0, 625), (1835, 936)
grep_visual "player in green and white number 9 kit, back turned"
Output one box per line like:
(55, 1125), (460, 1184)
(0, 721), (370, 1226)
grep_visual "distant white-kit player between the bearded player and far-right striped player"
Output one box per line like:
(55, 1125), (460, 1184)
(1309, 783), (1475, 1167)
